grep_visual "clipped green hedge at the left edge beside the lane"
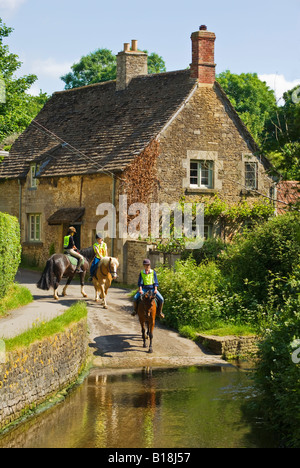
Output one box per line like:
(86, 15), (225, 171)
(0, 213), (21, 298)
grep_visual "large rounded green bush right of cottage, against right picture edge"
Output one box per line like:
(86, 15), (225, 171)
(219, 213), (300, 303)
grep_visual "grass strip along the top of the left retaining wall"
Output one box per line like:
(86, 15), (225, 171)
(4, 302), (87, 351)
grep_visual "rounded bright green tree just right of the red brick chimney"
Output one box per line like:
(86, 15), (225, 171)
(217, 70), (277, 145)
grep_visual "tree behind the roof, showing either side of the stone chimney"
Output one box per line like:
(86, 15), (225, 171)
(61, 49), (166, 89)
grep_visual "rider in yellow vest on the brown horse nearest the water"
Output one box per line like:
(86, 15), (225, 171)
(131, 259), (165, 318)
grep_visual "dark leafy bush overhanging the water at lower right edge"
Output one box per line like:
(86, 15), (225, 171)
(255, 265), (300, 448)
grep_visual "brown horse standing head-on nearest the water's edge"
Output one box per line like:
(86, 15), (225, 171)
(138, 290), (157, 353)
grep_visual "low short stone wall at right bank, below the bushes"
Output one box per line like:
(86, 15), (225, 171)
(197, 334), (259, 358)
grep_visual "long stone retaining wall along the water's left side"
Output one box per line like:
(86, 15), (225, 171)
(0, 319), (88, 430)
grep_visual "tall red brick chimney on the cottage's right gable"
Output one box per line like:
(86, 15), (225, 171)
(191, 25), (216, 85)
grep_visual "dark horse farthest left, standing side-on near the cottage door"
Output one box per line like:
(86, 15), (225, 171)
(37, 247), (95, 300)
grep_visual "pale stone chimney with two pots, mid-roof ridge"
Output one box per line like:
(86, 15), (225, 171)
(116, 40), (148, 91)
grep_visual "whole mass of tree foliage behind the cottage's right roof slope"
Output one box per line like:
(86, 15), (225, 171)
(217, 70), (300, 180)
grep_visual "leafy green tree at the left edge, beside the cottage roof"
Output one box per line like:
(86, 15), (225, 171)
(0, 18), (48, 142)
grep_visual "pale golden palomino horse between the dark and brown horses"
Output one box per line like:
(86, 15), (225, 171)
(93, 257), (119, 309)
